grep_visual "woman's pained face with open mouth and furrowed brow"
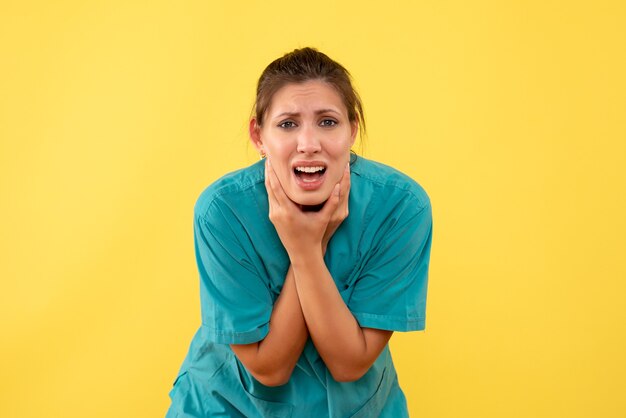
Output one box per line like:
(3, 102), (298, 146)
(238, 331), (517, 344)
(250, 80), (357, 205)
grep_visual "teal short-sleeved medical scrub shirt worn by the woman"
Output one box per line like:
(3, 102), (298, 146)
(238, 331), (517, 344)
(167, 157), (432, 418)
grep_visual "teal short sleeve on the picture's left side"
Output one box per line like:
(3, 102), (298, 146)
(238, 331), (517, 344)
(194, 202), (273, 344)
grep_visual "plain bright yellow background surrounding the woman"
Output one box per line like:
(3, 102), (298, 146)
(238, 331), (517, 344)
(0, 0), (626, 418)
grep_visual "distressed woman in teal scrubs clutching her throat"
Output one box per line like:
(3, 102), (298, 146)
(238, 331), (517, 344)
(167, 48), (432, 418)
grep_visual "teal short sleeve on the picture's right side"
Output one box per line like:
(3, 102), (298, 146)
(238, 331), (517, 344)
(348, 201), (432, 331)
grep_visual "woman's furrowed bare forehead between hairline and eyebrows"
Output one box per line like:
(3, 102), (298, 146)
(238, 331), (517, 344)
(268, 80), (347, 115)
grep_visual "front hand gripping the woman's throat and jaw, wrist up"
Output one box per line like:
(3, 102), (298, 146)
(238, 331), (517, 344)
(265, 159), (340, 261)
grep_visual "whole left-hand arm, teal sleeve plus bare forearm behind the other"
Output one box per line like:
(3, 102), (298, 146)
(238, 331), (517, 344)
(194, 204), (308, 386)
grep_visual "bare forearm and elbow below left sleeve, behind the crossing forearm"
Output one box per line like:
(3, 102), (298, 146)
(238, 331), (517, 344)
(231, 266), (309, 386)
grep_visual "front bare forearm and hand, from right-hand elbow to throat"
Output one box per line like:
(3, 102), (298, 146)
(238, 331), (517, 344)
(266, 161), (392, 381)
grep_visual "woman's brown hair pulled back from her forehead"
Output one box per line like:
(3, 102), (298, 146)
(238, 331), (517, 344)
(253, 48), (365, 137)
